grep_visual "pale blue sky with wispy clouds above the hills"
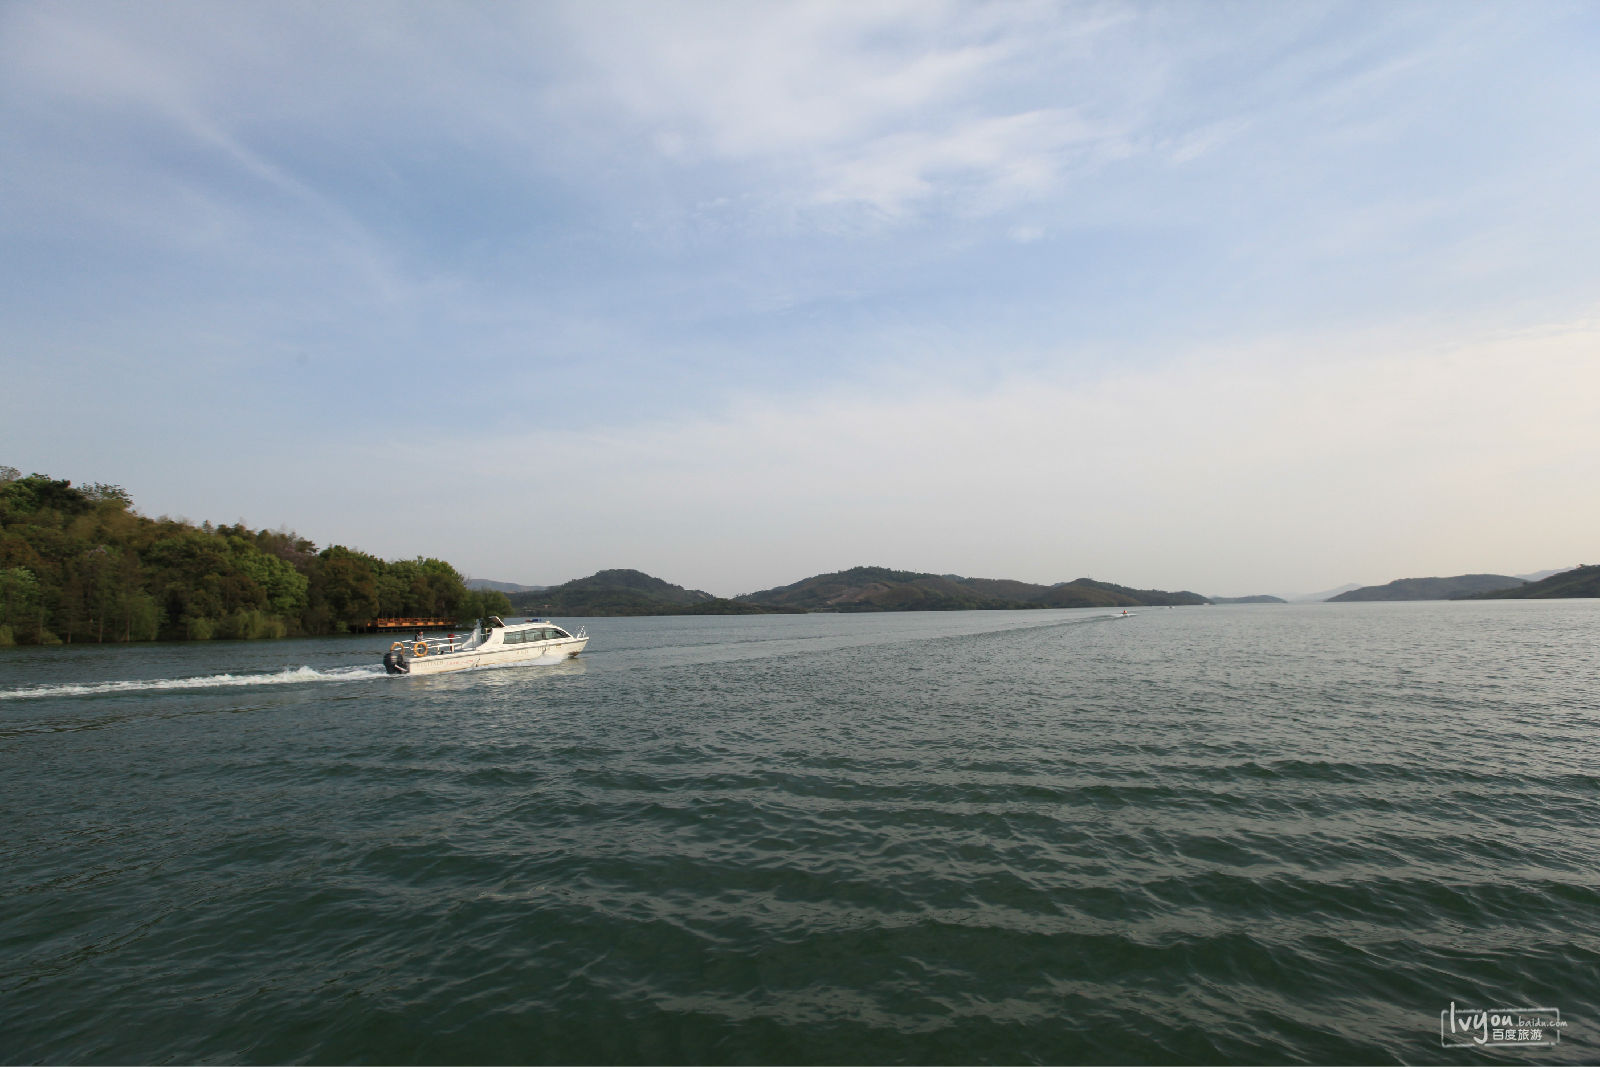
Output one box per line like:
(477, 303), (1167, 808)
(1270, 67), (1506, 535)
(0, 0), (1600, 595)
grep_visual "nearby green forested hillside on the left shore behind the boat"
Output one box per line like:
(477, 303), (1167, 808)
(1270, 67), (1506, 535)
(0, 467), (509, 645)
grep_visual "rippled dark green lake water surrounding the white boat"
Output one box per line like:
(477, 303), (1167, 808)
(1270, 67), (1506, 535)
(0, 601), (1600, 1062)
